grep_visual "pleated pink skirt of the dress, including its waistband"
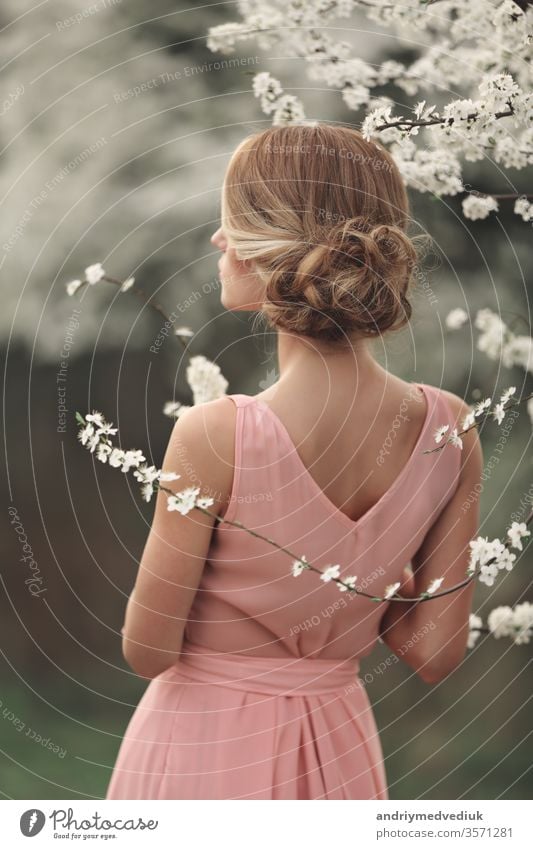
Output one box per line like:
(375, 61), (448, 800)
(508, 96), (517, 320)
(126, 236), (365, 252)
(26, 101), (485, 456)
(105, 642), (388, 800)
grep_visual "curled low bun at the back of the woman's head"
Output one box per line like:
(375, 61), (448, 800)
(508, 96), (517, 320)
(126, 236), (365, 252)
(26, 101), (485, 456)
(263, 217), (417, 341)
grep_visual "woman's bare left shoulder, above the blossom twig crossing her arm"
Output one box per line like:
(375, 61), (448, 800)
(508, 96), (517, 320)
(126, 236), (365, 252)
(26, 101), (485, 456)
(165, 397), (237, 506)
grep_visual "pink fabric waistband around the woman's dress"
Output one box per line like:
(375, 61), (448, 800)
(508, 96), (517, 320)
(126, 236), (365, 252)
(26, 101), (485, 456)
(164, 640), (359, 696)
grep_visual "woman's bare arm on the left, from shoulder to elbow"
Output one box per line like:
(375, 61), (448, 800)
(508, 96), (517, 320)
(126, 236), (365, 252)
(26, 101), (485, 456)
(122, 398), (236, 677)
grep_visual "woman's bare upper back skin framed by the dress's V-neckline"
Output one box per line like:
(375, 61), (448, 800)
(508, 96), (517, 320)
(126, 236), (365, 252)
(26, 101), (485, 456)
(247, 372), (434, 520)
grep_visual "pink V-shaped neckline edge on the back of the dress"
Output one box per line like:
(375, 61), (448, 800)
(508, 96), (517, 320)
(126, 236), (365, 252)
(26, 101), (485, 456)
(246, 381), (433, 531)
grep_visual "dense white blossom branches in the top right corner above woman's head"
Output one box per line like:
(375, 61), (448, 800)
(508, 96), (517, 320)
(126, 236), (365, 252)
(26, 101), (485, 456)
(207, 0), (533, 222)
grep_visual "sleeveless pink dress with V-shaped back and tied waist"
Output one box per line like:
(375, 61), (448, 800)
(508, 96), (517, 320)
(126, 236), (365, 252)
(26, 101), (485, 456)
(106, 383), (461, 799)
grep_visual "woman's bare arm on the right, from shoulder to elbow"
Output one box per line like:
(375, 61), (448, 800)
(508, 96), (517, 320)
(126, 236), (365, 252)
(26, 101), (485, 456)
(412, 392), (483, 680)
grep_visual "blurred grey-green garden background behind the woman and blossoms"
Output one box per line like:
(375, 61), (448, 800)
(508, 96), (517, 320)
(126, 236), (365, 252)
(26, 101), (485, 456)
(0, 0), (532, 799)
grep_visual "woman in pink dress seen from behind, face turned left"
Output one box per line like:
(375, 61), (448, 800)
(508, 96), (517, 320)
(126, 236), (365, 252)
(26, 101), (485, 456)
(106, 124), (482, 799)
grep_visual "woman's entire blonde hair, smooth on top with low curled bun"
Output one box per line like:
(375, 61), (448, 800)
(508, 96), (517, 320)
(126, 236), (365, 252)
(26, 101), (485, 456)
(222, 123), (424, 343)
